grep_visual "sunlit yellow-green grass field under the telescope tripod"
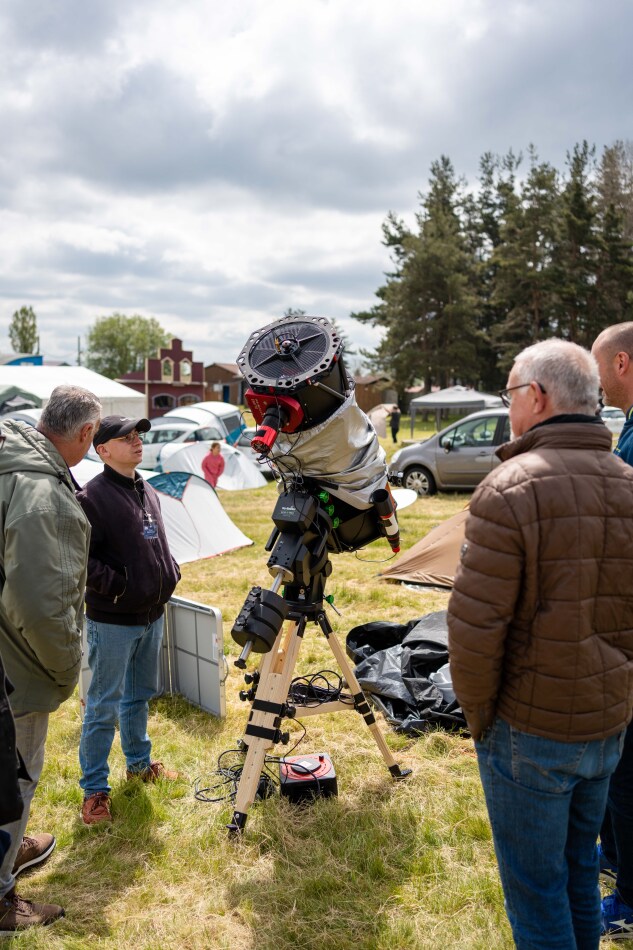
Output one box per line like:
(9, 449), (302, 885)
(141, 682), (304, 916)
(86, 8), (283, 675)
(12, 436), (620, 950)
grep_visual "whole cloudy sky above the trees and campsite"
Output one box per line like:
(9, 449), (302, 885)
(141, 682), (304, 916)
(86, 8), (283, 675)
(0, 0), (633, 363)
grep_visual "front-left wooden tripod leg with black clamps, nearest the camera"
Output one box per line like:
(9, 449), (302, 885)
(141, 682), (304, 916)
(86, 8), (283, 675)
(228, 618), (306, 831)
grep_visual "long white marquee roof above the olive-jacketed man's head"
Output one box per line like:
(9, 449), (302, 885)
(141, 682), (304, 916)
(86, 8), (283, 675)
(0, 365), (146, 418)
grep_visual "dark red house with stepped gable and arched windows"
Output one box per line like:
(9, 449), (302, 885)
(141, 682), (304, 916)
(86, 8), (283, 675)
(117, 338), (206, 419)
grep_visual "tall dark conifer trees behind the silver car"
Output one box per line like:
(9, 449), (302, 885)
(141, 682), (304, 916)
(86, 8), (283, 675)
(352, 142), (633, 394)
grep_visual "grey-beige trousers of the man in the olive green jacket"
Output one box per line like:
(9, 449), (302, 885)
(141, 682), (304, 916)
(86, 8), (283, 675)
(0, 712), (48, 897)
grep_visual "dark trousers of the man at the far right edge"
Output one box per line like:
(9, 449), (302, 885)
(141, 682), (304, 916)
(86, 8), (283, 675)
(600, 723), (633, 907)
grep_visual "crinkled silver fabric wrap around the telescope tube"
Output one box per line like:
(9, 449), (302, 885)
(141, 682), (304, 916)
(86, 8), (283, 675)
(271, 392), (387, 510)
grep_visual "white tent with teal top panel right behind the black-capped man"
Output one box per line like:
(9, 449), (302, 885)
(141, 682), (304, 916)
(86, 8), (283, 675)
(72, 458), (253, 564)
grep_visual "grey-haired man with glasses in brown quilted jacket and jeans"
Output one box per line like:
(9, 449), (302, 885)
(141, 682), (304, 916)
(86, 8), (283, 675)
(449, 340), (633, 950)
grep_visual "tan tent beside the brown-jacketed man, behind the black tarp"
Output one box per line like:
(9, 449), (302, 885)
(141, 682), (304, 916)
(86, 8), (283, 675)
(380, 508), (468, 587)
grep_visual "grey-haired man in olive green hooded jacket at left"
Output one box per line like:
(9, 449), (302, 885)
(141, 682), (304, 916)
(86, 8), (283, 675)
(0, 386), (101, 936)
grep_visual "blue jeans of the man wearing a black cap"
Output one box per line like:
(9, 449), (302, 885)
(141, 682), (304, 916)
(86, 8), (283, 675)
(79, 617), (164, 798)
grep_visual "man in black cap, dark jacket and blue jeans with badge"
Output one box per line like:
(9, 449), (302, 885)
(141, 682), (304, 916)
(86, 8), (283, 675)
(78, 416), (180, 825)
